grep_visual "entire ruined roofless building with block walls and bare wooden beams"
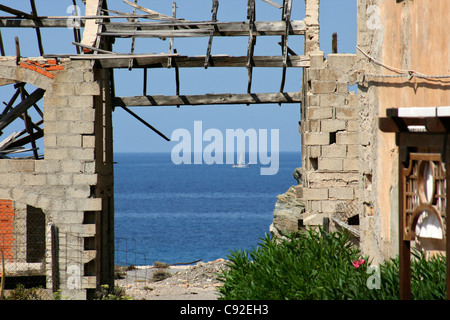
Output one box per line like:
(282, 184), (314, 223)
(0, 0), (450, 299)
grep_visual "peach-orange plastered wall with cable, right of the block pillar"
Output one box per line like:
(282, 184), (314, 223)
(357, 0), (450, 261)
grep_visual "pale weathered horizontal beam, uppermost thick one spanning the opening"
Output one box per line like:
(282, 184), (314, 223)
(102, 20), (306, 37)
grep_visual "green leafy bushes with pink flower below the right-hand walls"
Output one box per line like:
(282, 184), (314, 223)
(218, 228), (446, 300)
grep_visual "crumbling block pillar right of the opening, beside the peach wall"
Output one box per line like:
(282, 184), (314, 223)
(301, 52), (365, 225)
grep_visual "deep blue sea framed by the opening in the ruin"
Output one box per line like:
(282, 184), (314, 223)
(114, 152), (301, 265)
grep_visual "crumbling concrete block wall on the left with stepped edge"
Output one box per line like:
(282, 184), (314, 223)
(0, 57), (113, 299)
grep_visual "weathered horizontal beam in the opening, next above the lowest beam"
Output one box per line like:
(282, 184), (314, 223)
(93, 55), (310, 69)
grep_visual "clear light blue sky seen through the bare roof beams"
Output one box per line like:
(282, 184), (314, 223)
(0, 0), (356, 152)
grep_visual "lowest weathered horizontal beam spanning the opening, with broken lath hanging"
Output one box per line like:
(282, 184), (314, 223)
(112, 92), (302, 107)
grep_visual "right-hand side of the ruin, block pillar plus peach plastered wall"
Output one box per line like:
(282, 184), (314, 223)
(275, 0), (450, 263)
